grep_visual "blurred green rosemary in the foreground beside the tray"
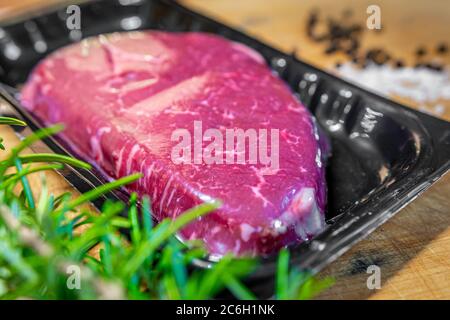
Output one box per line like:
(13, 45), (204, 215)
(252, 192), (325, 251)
(0, 117), (330, 299)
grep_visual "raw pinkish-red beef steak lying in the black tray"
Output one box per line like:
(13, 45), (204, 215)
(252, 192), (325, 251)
(22, 31), (326, 256)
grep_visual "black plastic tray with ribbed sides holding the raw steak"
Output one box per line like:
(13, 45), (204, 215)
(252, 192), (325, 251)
(0, 0), (450, 296)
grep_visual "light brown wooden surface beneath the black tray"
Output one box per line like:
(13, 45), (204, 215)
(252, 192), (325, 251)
(0, 0), (450, 299)
